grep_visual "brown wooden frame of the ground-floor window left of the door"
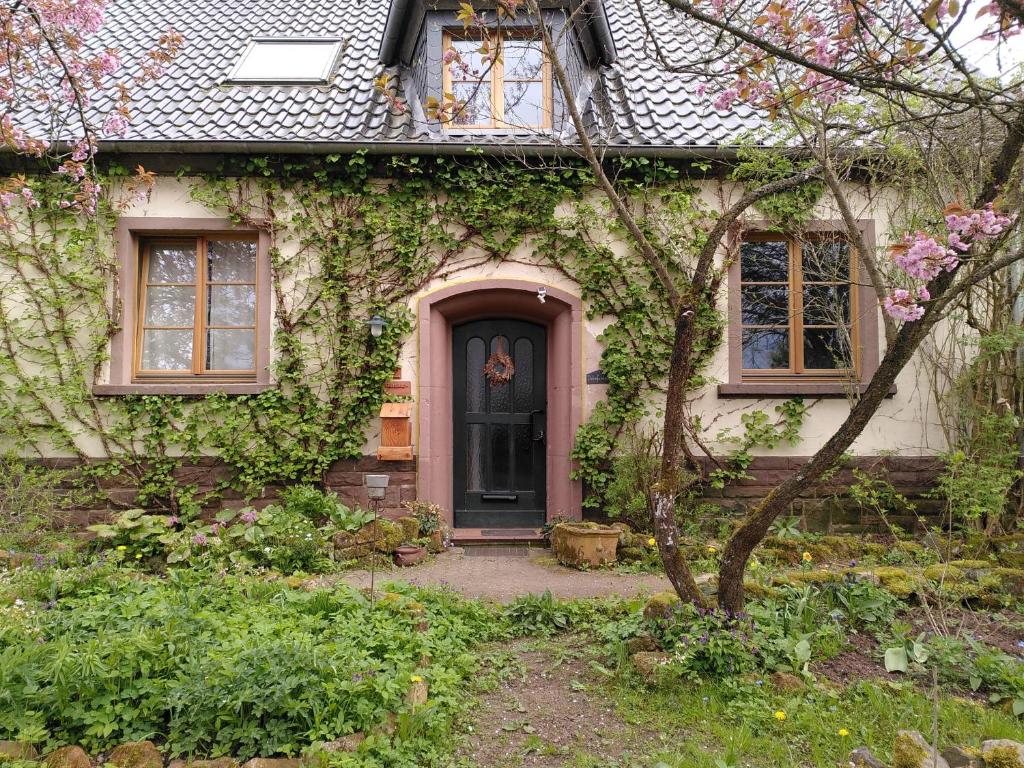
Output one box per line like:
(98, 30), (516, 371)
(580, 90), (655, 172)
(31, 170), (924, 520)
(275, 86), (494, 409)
(132, 233), (259, 382)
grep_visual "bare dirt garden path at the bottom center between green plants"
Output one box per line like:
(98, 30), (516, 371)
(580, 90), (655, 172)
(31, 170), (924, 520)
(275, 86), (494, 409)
(464, 638), (639, 768)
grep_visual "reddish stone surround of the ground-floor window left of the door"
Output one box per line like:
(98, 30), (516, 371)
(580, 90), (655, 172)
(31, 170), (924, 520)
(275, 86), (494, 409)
(92, 216), (273, 396)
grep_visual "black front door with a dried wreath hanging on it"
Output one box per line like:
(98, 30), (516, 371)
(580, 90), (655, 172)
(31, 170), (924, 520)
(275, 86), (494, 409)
(452, 319), (548, 528)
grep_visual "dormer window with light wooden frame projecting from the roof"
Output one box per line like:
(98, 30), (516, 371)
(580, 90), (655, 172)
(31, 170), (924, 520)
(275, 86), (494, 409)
(442, 29), (552, 129)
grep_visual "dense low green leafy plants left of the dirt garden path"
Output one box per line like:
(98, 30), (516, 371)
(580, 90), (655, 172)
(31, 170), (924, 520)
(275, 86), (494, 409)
(0, 569), (496, 765)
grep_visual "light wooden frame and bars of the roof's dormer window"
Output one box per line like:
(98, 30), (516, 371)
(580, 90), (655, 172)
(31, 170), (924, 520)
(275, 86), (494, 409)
(441, 27), (554, 131)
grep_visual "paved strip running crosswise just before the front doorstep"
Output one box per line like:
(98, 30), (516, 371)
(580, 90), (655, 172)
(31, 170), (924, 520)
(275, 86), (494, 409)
(341, 549), (672, 602)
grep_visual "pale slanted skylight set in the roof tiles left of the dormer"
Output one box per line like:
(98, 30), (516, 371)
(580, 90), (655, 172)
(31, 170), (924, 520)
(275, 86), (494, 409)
(227, 38), (341, 83)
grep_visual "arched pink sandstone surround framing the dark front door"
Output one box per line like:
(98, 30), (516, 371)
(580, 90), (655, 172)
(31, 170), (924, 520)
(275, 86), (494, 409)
(417, 280), (583, 531)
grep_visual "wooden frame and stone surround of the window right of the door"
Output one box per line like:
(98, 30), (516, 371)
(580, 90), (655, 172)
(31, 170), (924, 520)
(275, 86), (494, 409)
(718, 219), (880, 397)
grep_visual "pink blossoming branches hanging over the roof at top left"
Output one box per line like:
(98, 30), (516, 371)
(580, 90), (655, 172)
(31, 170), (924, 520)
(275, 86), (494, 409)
(0, 0), (181, 219)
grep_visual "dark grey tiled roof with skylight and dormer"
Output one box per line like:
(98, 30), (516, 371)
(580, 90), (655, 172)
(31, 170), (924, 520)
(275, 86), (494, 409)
(41, 0), (754, 153)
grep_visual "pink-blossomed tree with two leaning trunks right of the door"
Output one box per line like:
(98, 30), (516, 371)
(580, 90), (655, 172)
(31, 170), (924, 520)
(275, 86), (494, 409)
(382, 0), (1024, 610)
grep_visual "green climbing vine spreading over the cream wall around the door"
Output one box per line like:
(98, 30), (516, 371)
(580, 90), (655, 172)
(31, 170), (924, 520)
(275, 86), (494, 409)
(0, 154), (718, 514)
